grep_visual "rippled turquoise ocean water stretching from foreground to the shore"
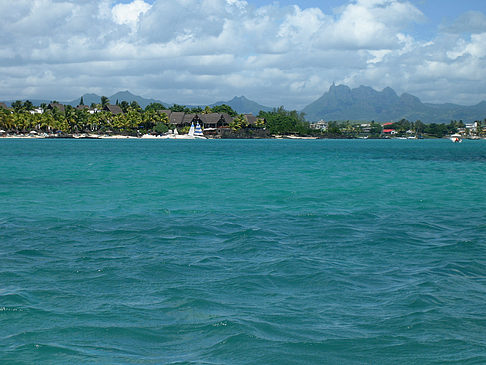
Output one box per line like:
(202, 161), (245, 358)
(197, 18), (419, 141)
(0, 140), (486, 364)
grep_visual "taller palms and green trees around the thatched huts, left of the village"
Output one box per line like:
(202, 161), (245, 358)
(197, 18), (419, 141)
(0, 96), (317, 135)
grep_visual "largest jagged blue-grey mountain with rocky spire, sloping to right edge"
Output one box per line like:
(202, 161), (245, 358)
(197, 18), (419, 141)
(302, 84), (486, 123)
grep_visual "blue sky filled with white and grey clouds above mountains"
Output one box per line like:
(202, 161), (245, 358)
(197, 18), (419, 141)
(0, 0), (486, 109)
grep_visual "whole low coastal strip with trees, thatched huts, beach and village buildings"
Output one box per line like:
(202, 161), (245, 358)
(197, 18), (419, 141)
(0, 96), (486, 139)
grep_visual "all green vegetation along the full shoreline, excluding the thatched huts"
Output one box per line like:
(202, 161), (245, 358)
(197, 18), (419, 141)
(0, 97), (486, 138)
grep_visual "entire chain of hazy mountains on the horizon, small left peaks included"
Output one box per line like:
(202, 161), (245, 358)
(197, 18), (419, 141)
(6, 84), (486, 123)
